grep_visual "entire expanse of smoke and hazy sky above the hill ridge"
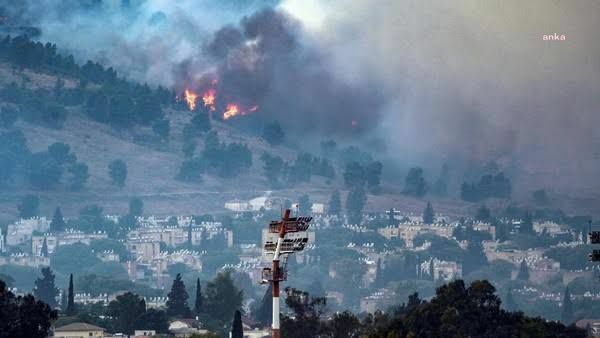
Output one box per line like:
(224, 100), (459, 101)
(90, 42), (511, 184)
(4, 0), (600, 191)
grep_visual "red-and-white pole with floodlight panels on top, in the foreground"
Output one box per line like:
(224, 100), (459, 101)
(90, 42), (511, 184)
(261, 209), (312, 338)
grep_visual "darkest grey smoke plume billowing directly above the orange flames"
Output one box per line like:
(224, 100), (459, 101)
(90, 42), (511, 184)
(183, 8), (382, 134)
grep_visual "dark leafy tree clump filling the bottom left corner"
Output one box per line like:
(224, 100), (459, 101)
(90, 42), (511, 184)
(0, 280), (57, 338)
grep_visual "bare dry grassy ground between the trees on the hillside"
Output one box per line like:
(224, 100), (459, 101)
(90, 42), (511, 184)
(0, 59), (593, 222)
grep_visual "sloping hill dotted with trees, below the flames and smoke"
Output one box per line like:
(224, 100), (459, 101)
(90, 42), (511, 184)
(0, 36), (412, 219)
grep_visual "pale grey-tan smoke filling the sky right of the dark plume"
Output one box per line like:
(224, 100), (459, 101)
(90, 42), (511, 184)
(284, 0), (600, 194)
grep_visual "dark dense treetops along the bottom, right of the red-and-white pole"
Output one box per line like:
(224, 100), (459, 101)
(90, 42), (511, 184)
(282, 280), (587, 338)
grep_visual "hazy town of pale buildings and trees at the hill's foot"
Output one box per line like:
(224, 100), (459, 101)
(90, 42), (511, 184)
(0, 193), (600, 337)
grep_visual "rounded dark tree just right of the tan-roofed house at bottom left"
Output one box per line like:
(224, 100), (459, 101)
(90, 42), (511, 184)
(107, 292), (146, 334)
